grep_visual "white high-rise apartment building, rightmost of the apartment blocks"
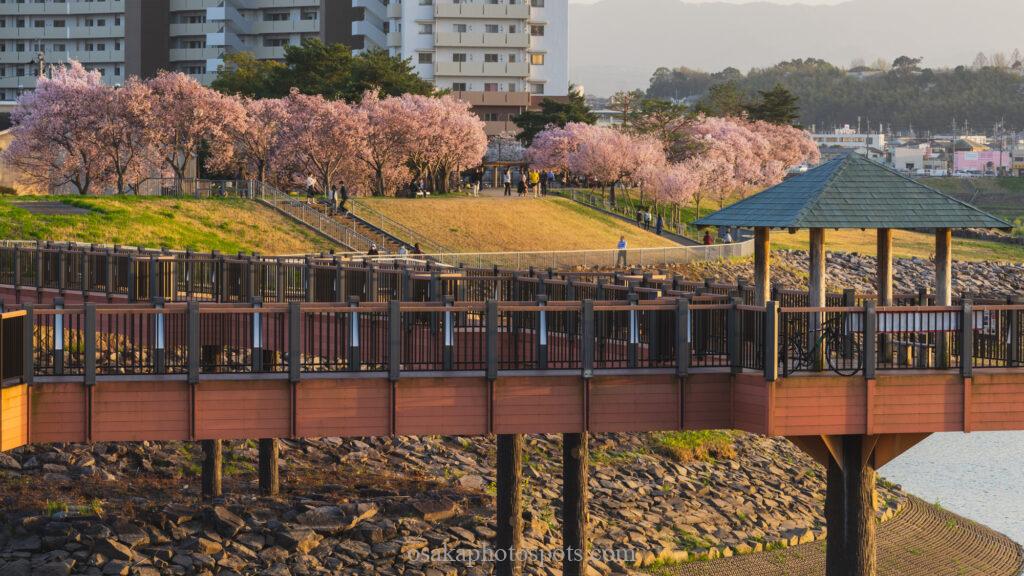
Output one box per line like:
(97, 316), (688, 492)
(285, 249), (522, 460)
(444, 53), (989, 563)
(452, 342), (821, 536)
(372, 0), (569, 135)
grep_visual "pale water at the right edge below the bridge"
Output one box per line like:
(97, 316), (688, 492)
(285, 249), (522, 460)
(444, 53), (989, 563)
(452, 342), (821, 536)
(880, 433), (1024, 543)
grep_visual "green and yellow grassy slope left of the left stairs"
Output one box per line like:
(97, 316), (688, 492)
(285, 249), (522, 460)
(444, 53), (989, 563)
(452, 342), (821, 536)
(0, 197), (331, 254)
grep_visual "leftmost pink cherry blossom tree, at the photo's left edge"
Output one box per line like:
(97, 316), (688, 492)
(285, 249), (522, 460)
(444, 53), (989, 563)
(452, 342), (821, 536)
(3, 61), (110, 195)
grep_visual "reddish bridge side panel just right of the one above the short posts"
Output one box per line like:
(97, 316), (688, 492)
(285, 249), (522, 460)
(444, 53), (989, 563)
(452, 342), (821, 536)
(296, 378), (391, 438)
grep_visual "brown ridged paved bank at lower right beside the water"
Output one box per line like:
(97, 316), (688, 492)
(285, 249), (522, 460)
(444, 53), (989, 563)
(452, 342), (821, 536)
(664, 497), (1024, 576)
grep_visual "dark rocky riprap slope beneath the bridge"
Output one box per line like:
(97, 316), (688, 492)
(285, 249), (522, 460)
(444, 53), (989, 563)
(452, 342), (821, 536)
(0, 434), (903, 576)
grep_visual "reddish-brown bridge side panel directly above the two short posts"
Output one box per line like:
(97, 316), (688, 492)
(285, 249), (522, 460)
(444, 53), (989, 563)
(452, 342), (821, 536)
(196, 380), (292, 440)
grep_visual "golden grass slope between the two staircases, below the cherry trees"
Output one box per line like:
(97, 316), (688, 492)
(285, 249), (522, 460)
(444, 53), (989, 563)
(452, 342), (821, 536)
(360, 197), (675, 252)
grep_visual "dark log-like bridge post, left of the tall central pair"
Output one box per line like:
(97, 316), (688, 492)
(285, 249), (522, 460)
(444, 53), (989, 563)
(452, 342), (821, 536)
(495, 434), (523, 576)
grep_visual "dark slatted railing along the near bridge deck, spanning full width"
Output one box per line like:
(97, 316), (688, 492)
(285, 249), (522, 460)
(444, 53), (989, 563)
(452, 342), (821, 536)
(6, 295), (1024, 383)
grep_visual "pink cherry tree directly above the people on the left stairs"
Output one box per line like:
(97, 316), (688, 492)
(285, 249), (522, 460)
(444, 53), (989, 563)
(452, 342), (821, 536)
(280, 90), (367, 190)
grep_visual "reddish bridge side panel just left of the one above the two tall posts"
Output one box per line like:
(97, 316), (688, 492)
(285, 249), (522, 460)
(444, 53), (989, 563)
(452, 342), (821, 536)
(395, 378), (487, 436)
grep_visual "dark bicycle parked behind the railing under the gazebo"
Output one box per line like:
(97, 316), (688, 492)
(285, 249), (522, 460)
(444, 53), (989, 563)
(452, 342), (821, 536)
(779, 313), (863, 376)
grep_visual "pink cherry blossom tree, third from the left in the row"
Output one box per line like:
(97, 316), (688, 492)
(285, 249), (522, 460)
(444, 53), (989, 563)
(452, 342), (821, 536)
(146, 72), (246, 178)
